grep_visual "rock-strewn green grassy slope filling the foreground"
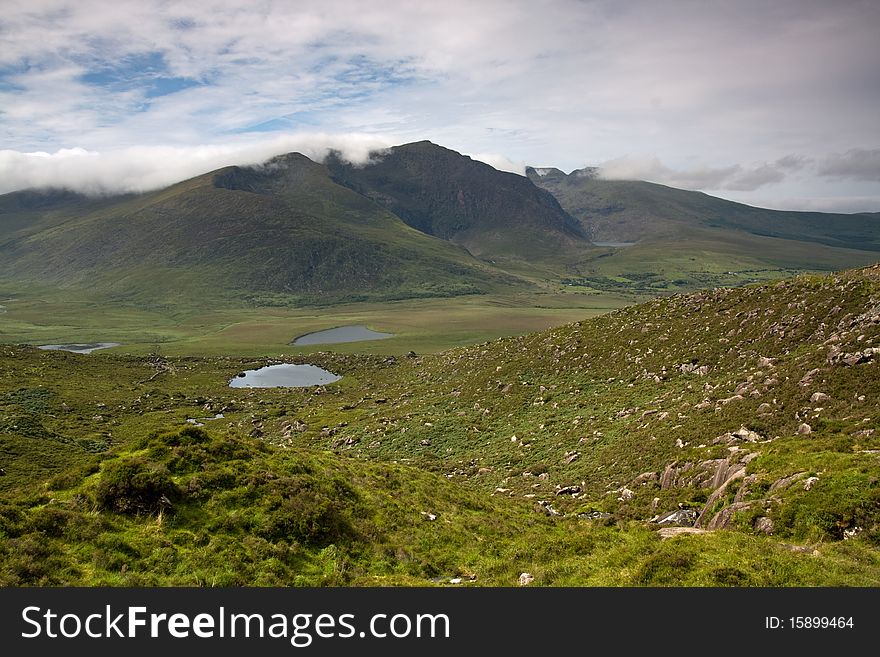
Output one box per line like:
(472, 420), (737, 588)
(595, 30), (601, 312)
(0, 268), (880, 585)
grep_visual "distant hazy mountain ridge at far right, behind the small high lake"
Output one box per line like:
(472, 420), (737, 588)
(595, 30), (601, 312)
(526, 167), (880, 251)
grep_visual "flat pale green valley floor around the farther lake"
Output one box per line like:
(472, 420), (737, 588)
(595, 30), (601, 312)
(0, 283), (632, 356)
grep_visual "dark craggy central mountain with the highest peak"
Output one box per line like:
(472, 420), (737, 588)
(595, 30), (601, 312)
(327, 141), (589, 261)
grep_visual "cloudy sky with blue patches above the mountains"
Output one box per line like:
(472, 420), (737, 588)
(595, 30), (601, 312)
(0, 0), (880, 212)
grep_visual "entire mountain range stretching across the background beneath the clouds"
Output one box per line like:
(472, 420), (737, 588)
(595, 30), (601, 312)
(0, 141), (880, 307)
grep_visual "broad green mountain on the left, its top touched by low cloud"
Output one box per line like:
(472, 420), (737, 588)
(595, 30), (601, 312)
(0, 153), (522, 303)
